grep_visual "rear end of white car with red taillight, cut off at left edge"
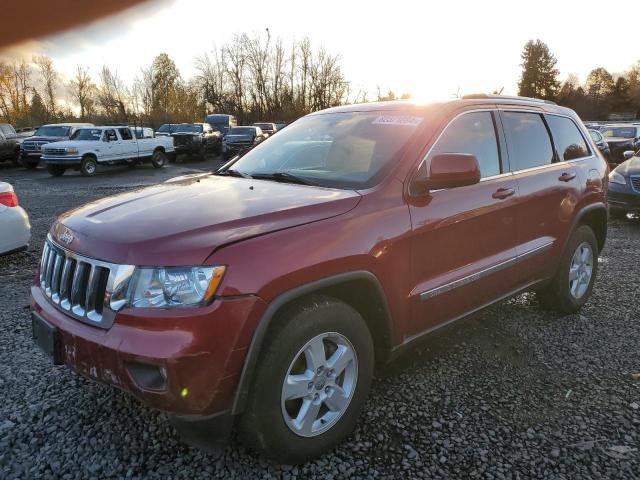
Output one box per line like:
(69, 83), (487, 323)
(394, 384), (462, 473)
(0, 182), (31, 255)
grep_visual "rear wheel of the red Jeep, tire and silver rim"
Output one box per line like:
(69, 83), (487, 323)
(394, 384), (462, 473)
(538, 225), (598, 314)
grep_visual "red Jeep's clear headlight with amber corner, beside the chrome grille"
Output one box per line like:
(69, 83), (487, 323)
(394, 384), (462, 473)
(129, 267), (225, 308)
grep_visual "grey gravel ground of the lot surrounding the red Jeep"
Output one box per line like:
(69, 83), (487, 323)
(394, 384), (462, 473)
(0, 159), (640, 479)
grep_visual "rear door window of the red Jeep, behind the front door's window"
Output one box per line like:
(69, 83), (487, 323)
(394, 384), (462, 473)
(502, 112), (553, 171)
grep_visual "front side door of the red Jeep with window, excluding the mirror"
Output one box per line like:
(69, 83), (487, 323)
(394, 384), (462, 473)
(406, 110), (518, 340)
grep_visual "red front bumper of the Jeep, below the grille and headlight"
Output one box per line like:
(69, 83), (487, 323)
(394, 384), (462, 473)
(31, 285), (264, 418)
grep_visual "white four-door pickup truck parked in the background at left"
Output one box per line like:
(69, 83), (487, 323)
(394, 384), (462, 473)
(41, 126), (175, 176)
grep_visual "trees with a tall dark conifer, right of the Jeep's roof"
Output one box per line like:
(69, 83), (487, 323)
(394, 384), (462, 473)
(518, 40), (640, 120)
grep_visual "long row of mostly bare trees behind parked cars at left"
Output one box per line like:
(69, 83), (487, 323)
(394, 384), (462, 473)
(0, 30), (350, 127)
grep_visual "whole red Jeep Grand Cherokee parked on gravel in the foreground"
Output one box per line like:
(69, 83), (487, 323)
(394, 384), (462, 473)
(31, 95), (608, 463)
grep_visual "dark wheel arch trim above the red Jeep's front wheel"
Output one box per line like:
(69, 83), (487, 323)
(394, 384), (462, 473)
(231, 270), (392, 415)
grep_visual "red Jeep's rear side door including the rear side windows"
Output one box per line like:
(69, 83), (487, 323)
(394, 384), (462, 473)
(500, 110), (589, 284)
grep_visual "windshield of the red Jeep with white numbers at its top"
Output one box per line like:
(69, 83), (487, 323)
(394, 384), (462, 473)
(230, 112), (423, 189)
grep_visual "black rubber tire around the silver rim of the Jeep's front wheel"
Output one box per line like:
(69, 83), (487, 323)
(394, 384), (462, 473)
(245, 301), (374, 463)
